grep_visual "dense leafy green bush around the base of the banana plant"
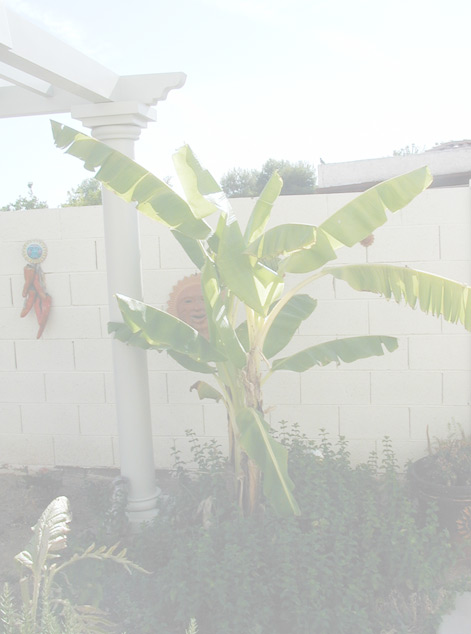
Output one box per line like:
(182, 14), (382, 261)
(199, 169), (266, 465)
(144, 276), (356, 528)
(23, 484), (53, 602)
(99, 426), (464, 634)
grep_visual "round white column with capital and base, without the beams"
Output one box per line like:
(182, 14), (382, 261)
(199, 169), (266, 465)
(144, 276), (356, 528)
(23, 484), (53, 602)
(71, 102), (160, 524)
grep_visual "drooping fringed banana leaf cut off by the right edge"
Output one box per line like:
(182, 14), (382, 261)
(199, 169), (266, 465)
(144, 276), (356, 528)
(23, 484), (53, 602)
(326, 264), (471, 331)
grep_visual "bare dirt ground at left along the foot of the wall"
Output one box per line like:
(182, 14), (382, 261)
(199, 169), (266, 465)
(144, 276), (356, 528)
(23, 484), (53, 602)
(0, 468), (123, 589)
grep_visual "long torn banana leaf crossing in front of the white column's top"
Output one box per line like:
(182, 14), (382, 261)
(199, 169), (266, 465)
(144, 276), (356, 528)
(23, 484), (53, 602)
(52, 122), (211, 239)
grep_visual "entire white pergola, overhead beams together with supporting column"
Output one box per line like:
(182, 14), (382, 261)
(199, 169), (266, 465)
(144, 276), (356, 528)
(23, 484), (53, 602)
(0, 0), (186, 523)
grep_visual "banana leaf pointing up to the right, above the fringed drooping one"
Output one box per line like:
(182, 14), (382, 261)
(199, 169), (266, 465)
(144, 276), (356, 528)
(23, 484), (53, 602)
(279, 167), (432, 273)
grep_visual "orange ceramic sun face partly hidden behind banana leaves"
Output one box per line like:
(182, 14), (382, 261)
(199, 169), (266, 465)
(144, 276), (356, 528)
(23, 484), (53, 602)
(168, 273), (209, 339)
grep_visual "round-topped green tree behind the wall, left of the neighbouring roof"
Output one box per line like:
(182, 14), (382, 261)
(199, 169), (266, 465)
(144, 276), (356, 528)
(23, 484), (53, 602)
(221, 159), (316, 198)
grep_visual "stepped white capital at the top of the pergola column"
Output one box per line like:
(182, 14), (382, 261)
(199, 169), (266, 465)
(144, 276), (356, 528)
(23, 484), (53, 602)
(71, 101), (157, 142)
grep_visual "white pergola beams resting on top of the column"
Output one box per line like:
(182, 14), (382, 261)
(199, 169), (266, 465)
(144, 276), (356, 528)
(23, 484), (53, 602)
(0, 0), (186, 118)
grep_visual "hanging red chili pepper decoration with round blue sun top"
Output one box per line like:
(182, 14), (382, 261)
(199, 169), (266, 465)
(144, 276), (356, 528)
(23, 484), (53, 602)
(20, 240), (52, 339)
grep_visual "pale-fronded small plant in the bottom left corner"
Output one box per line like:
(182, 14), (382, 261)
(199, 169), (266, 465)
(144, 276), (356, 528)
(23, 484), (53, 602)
(0, 496), (146, 634)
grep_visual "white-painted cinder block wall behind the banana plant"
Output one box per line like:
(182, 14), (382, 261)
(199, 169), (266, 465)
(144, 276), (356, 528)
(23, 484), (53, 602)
(0, 187), (471, 468)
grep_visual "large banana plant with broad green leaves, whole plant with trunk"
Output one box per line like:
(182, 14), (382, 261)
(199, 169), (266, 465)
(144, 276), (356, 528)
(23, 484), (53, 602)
(52, 122), (471, 516)
